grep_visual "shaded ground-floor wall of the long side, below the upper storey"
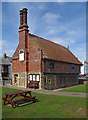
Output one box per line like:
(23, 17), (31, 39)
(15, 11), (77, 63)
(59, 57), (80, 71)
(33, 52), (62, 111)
(43, 74), (79, 90)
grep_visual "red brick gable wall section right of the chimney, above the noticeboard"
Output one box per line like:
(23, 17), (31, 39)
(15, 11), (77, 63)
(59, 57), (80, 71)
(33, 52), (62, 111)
(28, 36), (41, 73)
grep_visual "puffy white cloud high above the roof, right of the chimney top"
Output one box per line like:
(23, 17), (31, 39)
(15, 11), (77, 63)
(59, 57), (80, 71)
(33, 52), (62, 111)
(42, 12), (62, 24)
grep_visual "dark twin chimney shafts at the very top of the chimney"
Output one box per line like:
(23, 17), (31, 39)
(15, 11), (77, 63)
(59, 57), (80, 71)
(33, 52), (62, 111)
(19, 8), (28, 29)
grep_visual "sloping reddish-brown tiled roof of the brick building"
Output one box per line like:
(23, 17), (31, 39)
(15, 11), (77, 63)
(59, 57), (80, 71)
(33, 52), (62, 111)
(13, 34), (82, 65)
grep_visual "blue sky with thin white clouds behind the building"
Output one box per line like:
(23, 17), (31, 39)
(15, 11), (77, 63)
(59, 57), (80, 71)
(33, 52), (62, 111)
(0, 0), (86, 72)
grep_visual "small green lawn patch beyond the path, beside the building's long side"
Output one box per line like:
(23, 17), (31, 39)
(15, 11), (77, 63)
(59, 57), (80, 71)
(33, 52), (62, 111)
(61, 84), (88, 93)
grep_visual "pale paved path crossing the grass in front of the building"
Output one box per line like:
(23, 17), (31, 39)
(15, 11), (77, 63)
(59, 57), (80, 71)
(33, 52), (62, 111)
(4, 85), (88, 98)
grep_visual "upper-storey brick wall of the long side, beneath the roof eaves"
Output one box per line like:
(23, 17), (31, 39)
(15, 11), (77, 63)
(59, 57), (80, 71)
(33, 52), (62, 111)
(43, 60), (80, 73)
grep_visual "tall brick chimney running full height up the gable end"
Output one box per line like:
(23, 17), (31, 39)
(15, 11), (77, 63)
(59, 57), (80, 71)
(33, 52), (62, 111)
(18, 8), (29, 87)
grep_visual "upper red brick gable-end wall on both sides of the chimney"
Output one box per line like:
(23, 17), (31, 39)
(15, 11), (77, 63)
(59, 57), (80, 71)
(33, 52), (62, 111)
(12, 33), (41, 73)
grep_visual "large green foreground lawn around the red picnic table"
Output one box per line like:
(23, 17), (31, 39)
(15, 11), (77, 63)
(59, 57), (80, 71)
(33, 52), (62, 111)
(2, 87), (86, 118)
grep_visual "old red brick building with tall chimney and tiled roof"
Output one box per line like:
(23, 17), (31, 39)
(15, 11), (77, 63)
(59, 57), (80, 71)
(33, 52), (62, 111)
(12, 8), (82, 89)
